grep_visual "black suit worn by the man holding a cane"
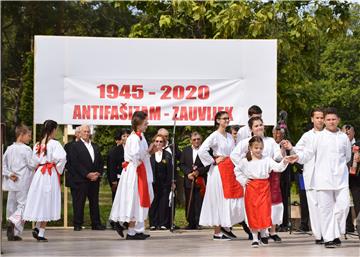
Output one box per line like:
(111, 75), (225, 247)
(180, 146), (210, 228)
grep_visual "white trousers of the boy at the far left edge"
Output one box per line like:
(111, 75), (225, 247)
(6, 191), (27, 236)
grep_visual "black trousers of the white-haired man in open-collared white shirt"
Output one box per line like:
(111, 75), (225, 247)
(71, 181), (101, 227)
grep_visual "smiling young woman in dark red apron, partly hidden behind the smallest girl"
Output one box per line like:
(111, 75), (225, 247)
(230, 117), (285, 244)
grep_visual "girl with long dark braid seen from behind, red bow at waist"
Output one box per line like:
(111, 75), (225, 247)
(24, 120), (66, 242)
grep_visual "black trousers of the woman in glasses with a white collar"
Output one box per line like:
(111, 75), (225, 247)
(149, 186), (171, 228)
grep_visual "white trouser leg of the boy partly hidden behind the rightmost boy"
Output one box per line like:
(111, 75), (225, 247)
(306, 189), (321, 240)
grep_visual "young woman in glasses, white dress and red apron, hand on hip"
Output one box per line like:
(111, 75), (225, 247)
(198, 111), (244, 240)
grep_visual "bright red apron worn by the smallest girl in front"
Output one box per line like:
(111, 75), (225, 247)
(245, 179), (272, 229)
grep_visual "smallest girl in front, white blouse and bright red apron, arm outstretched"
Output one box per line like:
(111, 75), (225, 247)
(235, 136), (291, 247)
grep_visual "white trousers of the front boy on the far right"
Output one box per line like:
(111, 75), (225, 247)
(317, 187), (350, 242)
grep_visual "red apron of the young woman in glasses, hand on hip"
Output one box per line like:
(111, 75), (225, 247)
(218, 157), (244, 199)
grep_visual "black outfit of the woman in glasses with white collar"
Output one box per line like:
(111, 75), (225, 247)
(149, 150), (172, 228)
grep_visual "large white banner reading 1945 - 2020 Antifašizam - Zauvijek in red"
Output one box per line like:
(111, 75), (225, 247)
(34, 36), (276, 126)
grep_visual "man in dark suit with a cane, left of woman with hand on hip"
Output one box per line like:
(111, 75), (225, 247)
(180, 132), (209, 229)
